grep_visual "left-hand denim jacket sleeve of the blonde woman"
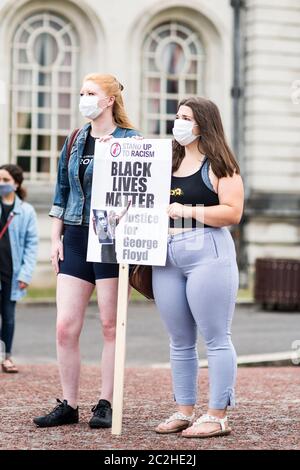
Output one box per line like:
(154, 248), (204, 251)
(49, 137), (70, 219)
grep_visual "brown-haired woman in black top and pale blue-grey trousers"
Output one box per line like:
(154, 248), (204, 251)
(153, 97), (244, 438)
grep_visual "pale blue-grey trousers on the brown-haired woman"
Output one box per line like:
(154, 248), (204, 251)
(153, 227), (238, 409)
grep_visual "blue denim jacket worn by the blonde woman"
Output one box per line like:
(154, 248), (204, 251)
(49, 123), (139, 225)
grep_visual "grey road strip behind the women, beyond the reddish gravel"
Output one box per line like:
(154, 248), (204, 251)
(10, 302), (300, 366)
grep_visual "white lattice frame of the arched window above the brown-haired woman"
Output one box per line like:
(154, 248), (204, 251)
(141, 20), (206, 138)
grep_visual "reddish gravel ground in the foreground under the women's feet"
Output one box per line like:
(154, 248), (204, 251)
(0, 365), (300, 450)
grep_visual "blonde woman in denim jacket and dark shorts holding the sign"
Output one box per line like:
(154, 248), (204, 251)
(34, 74), (138, 428)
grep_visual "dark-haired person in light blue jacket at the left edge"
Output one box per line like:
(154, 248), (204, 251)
(0, 164), (38, 373)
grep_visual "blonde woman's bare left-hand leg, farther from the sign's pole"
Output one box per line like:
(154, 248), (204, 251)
(56, 274), (94, 408)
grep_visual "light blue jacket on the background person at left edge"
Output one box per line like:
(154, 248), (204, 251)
(0, 195), (38, 300)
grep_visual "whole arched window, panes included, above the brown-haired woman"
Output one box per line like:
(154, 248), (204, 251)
(142, 22), (204, 137)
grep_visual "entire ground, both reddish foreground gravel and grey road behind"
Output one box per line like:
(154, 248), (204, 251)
(0, 303), (300, 450)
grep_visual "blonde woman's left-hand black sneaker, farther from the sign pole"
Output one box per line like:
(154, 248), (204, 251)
(33, 398), (79, 428)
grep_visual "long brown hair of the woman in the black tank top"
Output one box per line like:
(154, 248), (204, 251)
(172, 97), (240, 178)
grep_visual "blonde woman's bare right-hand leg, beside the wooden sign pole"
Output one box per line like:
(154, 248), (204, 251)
(96, 278), (118, 403)
